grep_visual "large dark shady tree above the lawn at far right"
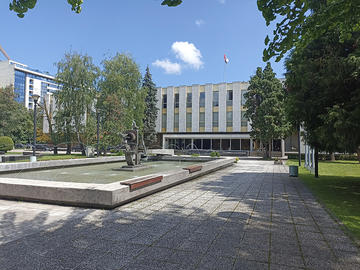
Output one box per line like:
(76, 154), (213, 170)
(286, 31), (360, 161)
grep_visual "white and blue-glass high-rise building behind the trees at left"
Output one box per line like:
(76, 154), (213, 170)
(0, 60), (59, 109)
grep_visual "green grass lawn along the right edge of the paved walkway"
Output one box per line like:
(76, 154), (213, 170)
(288, 160), (360, 240)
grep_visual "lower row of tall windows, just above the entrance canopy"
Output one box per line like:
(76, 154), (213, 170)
(161, 111), (247, 129)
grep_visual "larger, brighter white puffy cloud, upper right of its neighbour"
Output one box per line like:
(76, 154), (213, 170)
(171, 41), (204, 70)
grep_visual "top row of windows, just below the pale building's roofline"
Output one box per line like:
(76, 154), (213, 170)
(162, 90), (247, 109)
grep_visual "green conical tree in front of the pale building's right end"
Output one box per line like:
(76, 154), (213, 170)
(245, 63), (291, 157)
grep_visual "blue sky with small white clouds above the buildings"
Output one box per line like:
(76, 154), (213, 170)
(0, 0), (285, 87)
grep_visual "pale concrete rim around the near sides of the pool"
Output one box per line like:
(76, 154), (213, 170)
(0, 158), (235, 209)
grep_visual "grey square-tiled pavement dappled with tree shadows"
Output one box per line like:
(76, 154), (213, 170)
(0, 160), (360, 270)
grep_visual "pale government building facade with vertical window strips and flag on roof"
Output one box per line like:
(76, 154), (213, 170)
(157, 82), (256, 151)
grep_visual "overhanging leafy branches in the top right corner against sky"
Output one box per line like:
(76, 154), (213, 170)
(257, 0), (360, 61)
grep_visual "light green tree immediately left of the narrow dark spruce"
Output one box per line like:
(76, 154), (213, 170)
(98, 54), (145, 148)
